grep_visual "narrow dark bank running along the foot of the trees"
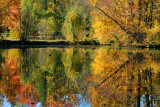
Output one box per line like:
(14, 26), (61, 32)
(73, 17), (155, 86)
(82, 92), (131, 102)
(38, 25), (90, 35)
(0, 40), (160, 48)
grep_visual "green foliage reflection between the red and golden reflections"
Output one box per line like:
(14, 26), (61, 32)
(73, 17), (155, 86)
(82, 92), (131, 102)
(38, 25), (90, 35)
(17, 48), (93, 107)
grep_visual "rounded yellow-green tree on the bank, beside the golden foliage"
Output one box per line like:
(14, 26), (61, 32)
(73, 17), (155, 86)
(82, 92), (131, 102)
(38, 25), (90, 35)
(62, 1), (90, 40)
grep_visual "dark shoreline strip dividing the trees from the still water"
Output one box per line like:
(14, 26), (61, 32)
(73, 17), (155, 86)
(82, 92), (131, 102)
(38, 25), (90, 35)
(0, 40), (160, 49)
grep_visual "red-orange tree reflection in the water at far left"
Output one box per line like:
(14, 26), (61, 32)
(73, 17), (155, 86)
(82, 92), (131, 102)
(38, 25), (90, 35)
(0, 50), (37, 107)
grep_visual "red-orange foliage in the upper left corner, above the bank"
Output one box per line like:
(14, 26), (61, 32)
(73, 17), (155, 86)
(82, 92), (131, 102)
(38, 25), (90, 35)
(0, 0), (20, 30)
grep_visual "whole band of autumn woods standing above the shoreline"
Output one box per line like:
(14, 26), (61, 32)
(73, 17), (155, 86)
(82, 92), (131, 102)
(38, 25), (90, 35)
(0, 0), (160, 45)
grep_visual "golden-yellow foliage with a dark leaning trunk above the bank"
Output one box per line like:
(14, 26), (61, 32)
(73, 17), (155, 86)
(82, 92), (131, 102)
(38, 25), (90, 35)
(90, 0), (160, 44)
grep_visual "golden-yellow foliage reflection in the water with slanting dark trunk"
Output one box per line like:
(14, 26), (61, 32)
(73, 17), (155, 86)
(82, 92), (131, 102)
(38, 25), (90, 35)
(88, 48), (160, 107)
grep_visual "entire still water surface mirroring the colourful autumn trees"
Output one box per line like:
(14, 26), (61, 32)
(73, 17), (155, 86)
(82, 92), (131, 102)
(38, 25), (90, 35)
(0, 47), (160, 107)
